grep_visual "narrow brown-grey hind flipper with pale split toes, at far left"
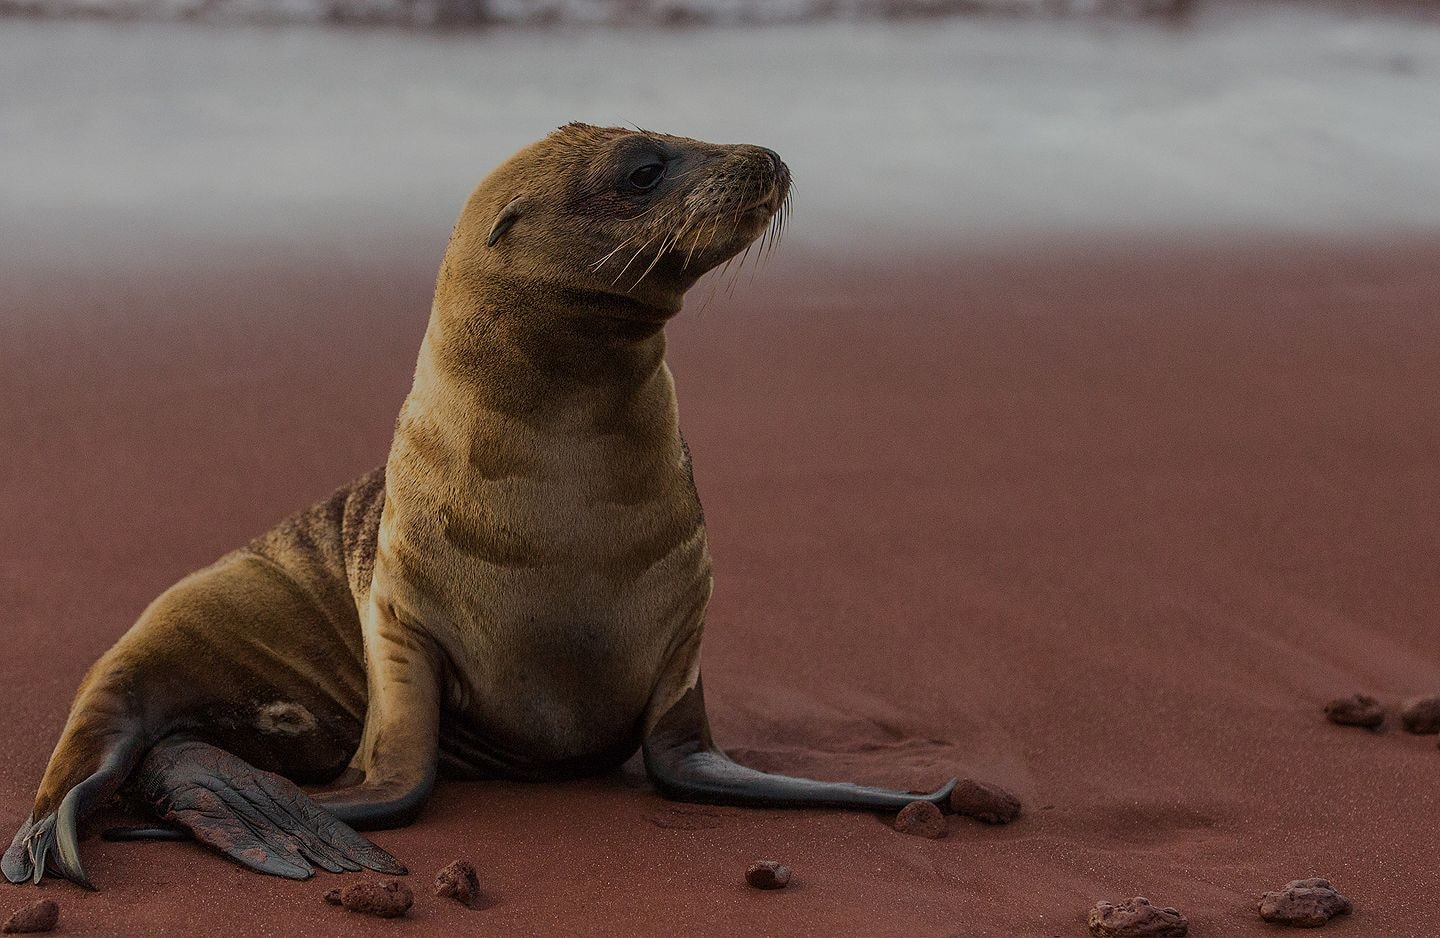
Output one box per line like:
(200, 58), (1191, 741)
(0, 671), (151, 889)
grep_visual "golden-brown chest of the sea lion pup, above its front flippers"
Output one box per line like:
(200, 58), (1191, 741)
(379, 386), (710, 762)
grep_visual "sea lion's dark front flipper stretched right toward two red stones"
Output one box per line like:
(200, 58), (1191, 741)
(644, 677), (955, 811)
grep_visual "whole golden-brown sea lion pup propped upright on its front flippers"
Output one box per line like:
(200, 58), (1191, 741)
(11, 124), (953, 885)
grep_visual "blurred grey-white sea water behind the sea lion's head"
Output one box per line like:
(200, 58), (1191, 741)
(0, 6), (1440, 274)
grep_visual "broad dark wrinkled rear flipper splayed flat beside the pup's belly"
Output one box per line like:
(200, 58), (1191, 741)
(135, 739), (405, 879)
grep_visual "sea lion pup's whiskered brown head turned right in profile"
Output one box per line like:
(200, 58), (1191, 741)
(441, 124), (791, 320)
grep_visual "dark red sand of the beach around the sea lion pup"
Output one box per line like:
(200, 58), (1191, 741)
(0, 244), (1440, 935)
